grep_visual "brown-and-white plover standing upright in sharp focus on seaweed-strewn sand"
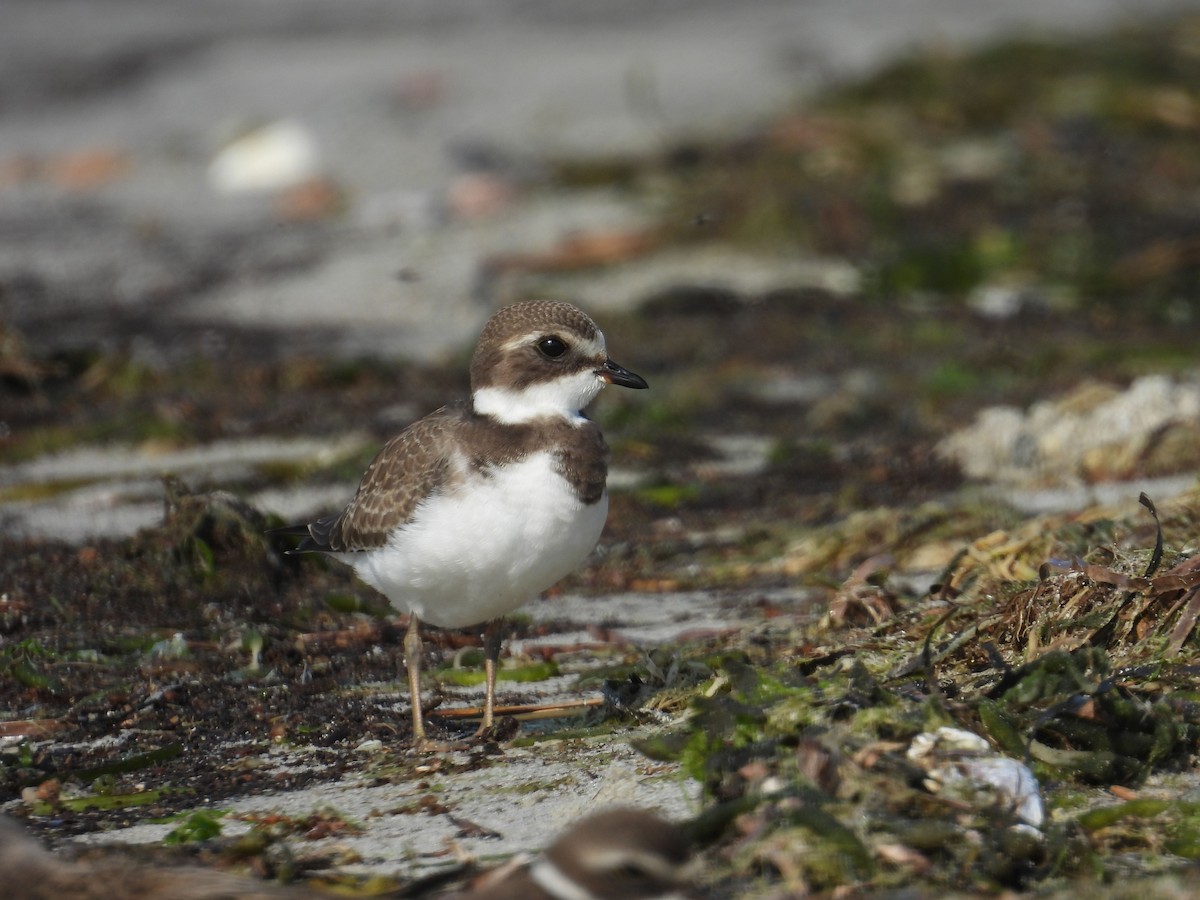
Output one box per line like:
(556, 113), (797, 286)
(274, 302), (647, 743)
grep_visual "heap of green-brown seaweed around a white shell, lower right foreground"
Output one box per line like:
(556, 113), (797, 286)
(641, 493), (1200, 895)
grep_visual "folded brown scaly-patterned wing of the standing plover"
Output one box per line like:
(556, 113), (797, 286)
(296, 407), (463, 552)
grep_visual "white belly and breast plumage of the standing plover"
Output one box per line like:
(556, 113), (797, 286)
(337, 454), (608, 628)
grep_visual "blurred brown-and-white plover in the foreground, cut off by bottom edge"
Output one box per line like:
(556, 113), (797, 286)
(455, 809), (691, 900)
